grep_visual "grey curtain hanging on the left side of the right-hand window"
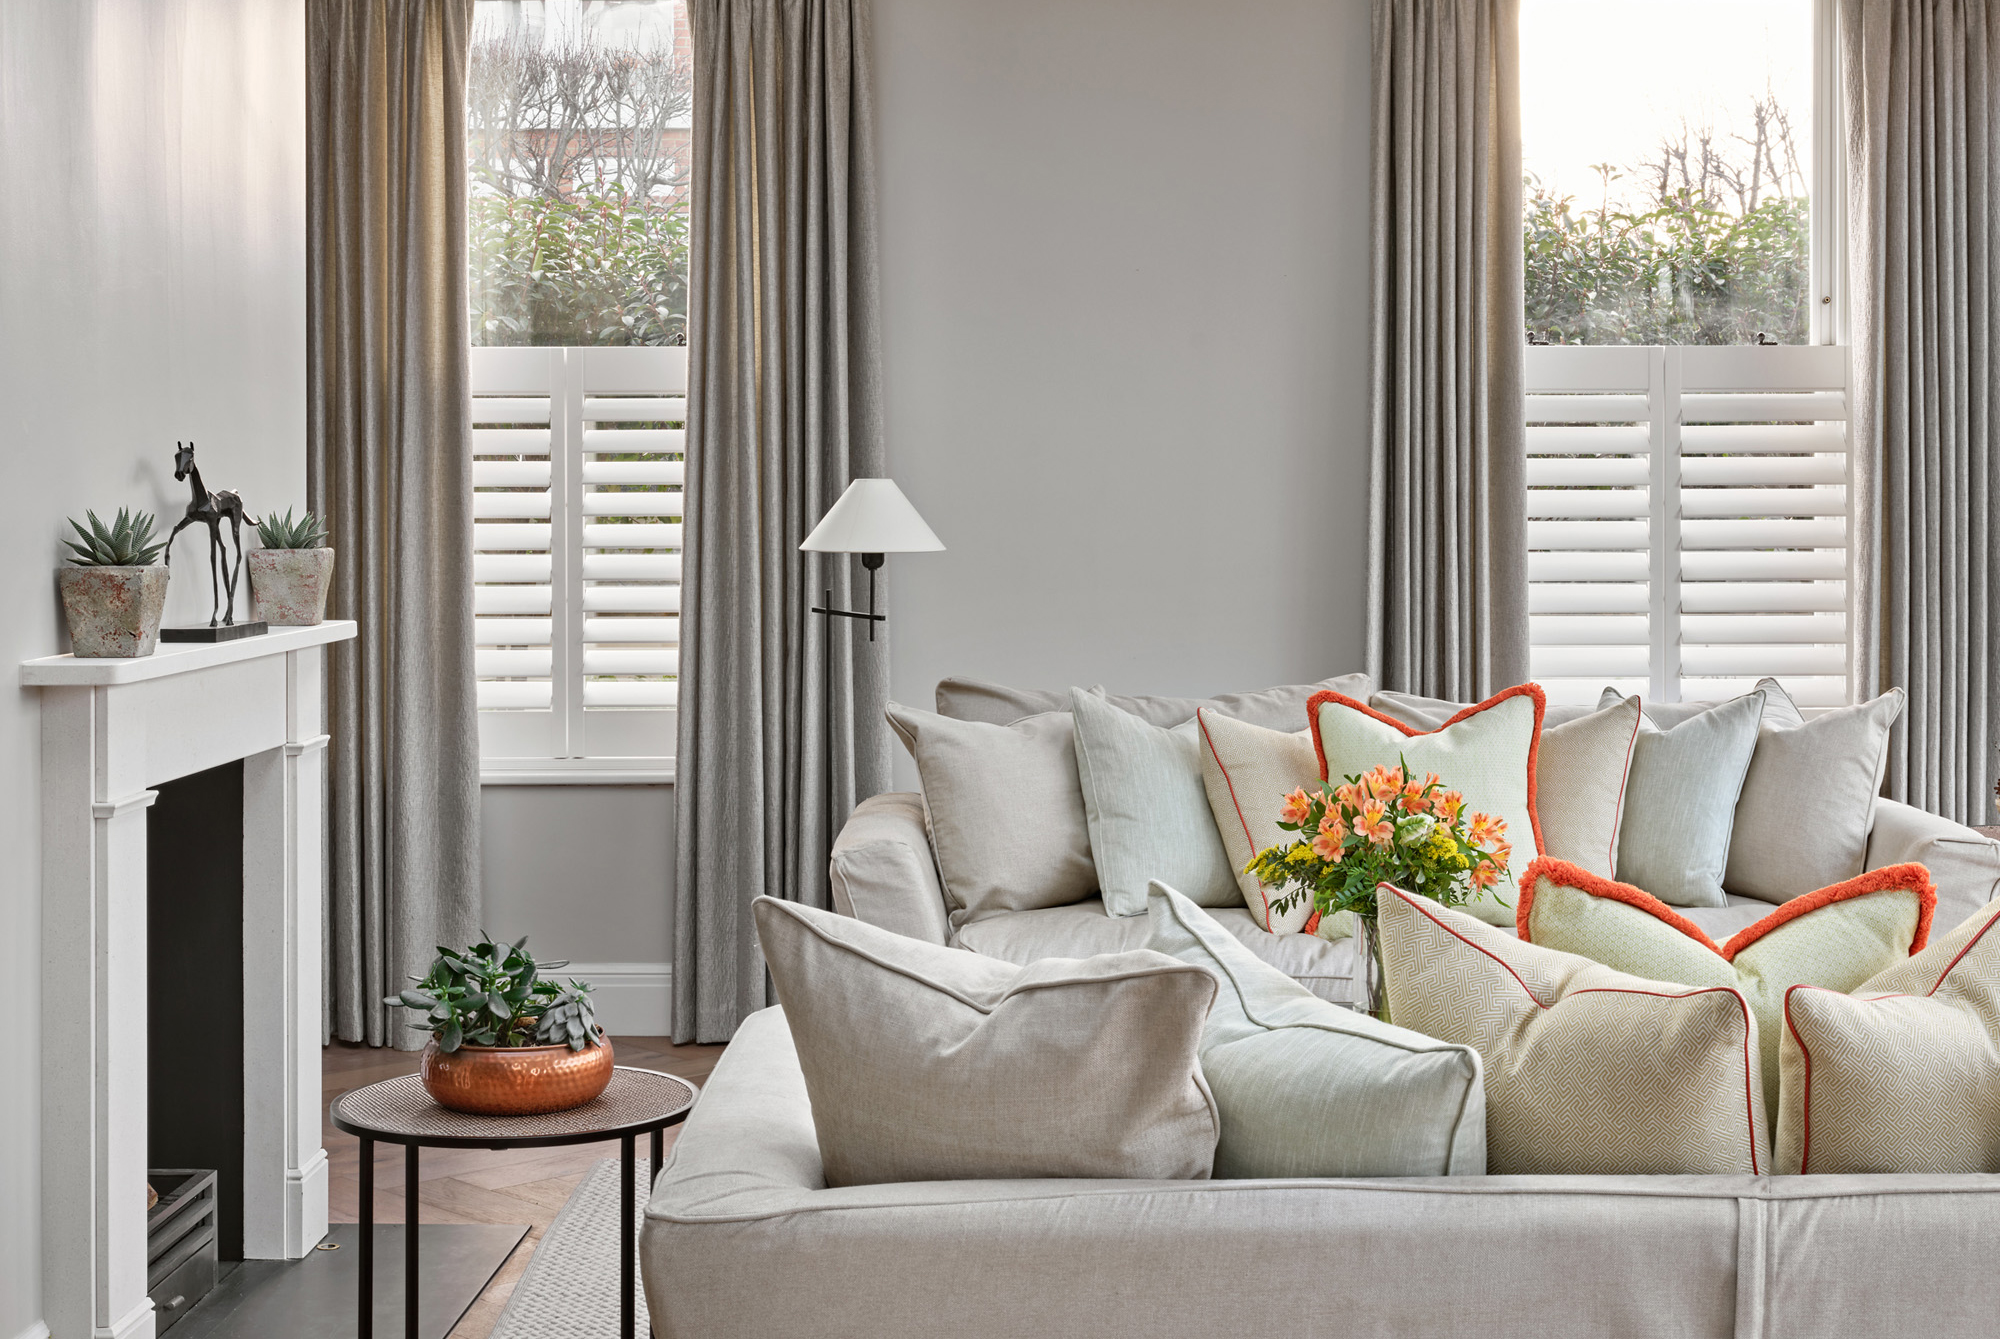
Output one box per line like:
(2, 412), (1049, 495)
(1368, 0), (1528, 699)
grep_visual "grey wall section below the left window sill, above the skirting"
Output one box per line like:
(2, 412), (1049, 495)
(480, 785), (674, 963)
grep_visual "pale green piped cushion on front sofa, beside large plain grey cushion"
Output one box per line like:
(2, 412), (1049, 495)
(1146, 883), (1486, 1179)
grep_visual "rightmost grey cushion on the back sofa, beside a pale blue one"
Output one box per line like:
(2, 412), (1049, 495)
(1722, 679), (1904, 901)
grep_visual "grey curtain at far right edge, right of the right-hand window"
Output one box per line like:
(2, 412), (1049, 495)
(1842, 0), (2000, 823)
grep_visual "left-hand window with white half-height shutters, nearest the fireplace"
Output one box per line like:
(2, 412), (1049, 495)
(466, 0), (692, 781)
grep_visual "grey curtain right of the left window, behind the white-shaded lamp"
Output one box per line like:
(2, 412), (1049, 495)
(674, 0), (890, 1041)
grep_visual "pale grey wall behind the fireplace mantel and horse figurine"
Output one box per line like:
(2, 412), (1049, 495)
(0, 0), (308, 1339)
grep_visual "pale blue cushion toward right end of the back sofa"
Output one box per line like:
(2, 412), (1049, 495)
(1606, 689), (1764, 907)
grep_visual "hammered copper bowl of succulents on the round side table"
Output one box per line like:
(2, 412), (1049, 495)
(384, 937), (612, 1115)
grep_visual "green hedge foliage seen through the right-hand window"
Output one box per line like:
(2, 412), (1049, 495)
(1522, 180), (1810, 344)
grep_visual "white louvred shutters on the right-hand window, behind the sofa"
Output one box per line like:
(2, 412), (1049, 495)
(1528, 346), (1848, 705)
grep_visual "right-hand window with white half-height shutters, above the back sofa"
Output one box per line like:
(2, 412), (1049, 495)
(1522, 0), (1850, 705)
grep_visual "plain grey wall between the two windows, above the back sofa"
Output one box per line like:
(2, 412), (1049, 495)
(874, 0), (1370, 755)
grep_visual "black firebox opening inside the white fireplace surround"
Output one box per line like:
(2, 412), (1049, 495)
(146, 761), (244, 1259)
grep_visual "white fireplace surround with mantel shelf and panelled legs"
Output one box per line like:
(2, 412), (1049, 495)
(20, 622), (356, 1339)
